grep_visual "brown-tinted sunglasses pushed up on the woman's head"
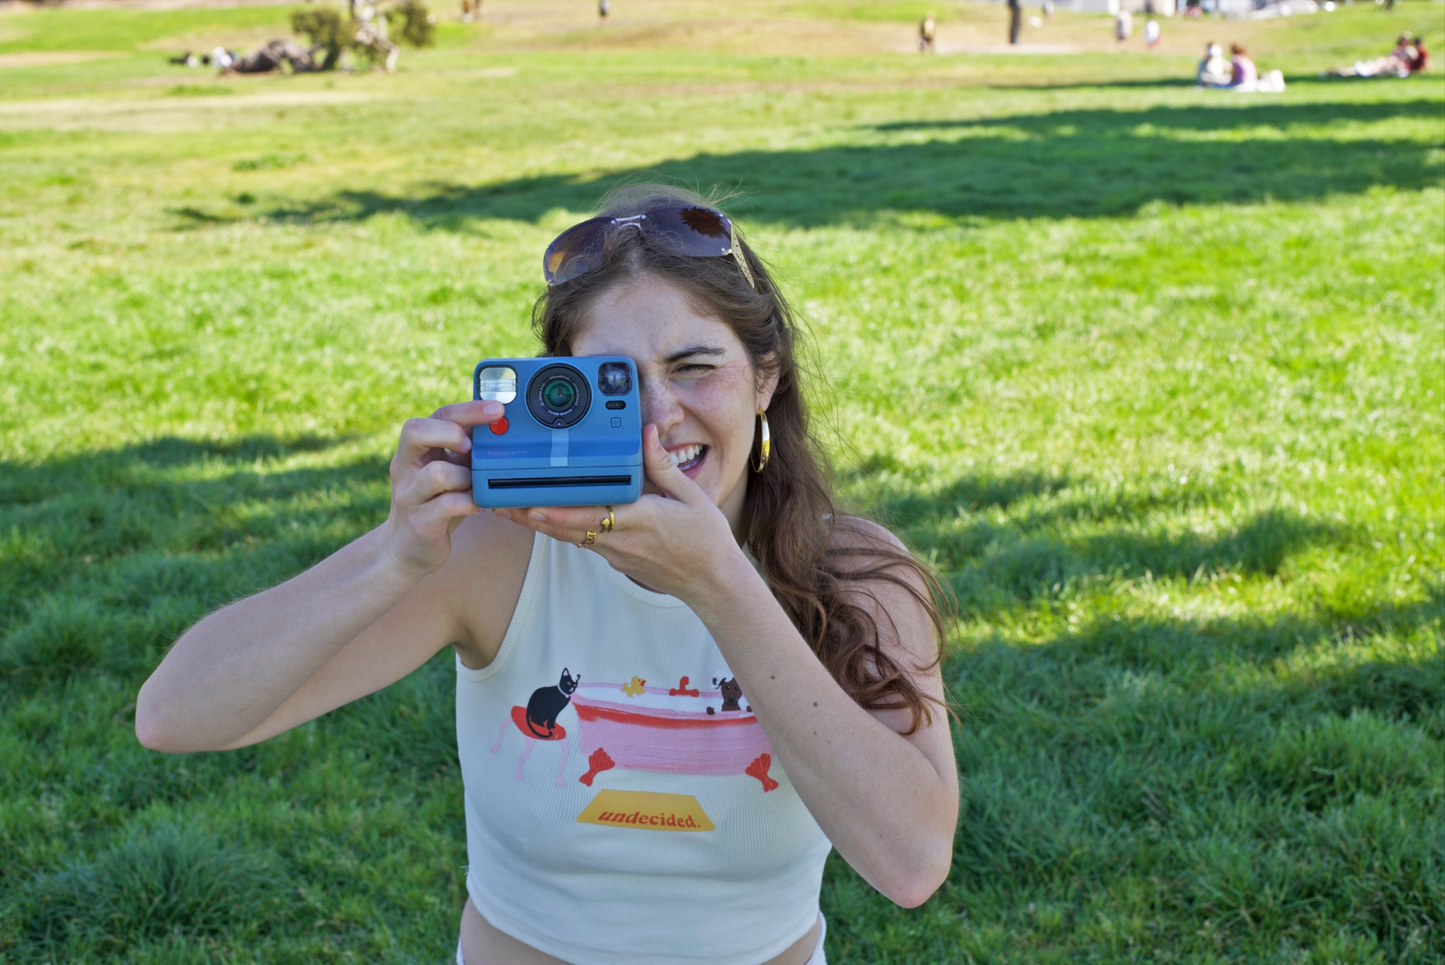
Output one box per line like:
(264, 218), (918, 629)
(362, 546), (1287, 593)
(542, 204), (757, 292)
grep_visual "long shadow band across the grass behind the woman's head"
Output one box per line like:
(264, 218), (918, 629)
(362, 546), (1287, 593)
(195, 98), (1441, 231)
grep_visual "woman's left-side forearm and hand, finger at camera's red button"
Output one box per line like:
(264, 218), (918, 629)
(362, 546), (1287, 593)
(136, 403), (514, 753)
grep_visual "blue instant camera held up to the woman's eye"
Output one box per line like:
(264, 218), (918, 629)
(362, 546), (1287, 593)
(471, 355), (643, 509)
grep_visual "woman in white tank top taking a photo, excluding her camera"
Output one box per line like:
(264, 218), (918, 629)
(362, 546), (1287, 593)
(136, 188), (958, 965)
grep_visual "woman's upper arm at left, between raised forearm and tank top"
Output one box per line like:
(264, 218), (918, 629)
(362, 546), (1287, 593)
(221, 513), (532, 750)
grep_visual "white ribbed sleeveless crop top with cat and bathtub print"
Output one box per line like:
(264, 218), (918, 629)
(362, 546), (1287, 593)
(457, 535), (831, 965)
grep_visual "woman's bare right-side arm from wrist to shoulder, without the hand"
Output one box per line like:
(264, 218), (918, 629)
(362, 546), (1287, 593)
(691, 553), (958, 907)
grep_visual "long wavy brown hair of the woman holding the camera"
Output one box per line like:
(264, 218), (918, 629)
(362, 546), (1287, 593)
(532, 185), (946, 734)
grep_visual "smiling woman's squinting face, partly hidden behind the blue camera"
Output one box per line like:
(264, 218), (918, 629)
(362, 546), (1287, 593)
(572, 274), (775, 532)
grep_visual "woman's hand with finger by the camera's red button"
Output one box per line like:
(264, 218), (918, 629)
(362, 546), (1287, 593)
(381, 402), (504, 575)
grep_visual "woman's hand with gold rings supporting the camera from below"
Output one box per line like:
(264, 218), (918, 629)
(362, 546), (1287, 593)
(494, 423), (741, 604)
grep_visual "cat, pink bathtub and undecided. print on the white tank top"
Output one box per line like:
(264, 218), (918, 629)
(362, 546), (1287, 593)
(491, 669), (779, 808)
